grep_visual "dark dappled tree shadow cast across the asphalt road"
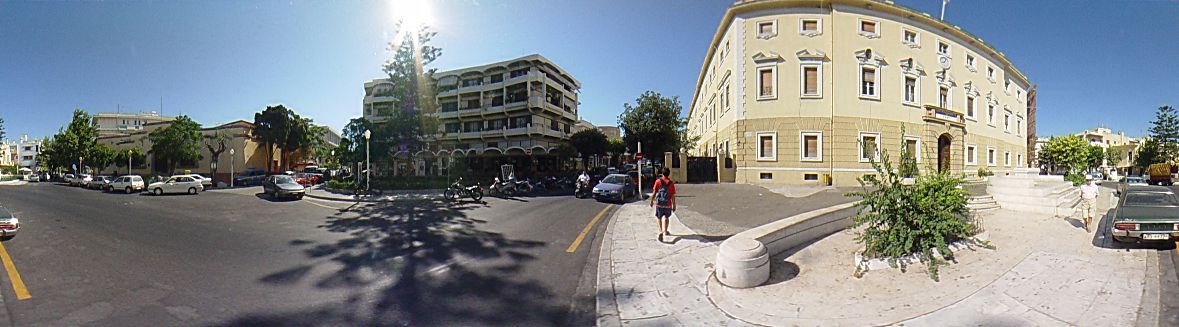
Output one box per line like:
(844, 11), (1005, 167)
(216, 197), (568, 326)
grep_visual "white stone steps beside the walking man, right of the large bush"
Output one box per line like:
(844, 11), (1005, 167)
(987, 169), (1081, 217)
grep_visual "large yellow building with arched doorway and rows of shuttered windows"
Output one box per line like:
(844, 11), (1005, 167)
(689, 0), (1029, 185)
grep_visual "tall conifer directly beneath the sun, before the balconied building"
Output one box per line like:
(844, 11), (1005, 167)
(377, 24), (442, 157)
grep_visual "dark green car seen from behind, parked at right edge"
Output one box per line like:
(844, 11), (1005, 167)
(1111, 185), (1179, 243)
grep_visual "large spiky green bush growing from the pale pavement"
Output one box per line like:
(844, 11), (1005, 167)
(849, 138), (989, 281)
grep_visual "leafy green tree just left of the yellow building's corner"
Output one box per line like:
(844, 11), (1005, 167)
(618, 91), (687, 158)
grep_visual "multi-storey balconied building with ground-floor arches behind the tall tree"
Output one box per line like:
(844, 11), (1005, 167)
(363, 54), (581, 175)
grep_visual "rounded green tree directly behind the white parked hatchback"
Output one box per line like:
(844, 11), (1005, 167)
(147, 116), (202, 174)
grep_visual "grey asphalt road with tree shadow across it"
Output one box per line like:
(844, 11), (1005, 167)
(0, 183), (613, 326)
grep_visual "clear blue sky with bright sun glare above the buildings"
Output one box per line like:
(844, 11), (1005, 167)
(0, 0), (1179, 138)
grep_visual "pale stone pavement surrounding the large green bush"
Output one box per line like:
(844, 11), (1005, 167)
(598, 185), (1159, 326)
